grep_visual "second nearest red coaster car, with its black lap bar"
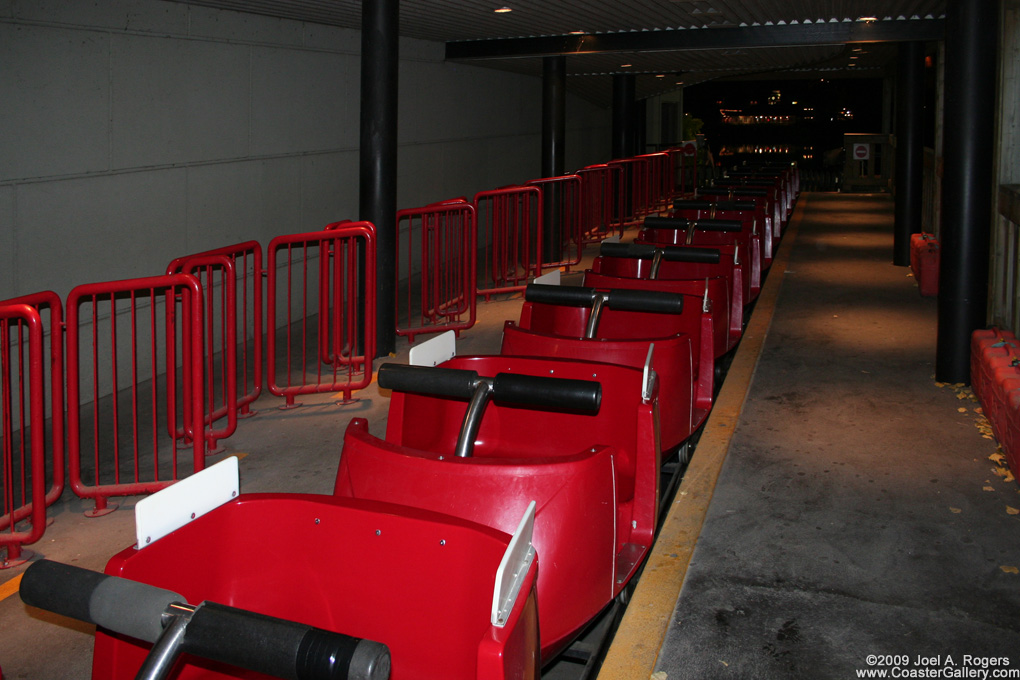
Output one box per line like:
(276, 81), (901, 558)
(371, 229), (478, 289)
(335, 356), (660, 662)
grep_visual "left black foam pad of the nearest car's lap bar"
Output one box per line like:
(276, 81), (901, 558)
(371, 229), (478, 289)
(20, 560), (187, 642)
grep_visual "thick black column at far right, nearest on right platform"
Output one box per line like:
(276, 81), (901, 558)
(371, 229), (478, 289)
(935, 0), (1000, 382)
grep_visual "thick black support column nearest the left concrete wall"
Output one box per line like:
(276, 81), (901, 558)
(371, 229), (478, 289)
(358, 0), (400, 357)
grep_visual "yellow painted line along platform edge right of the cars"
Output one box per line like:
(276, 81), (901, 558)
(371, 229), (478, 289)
(598, 196), (808, 680)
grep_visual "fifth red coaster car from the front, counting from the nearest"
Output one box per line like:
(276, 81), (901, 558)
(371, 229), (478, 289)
(634, 217), (762, 302)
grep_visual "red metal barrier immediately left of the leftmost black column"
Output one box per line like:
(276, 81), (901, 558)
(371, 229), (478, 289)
(266, 222), (376, 407)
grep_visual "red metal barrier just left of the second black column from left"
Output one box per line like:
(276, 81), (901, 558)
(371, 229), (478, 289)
(473, 187), (543, 301)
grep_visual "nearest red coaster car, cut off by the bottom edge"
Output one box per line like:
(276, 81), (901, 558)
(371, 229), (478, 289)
(66, 491), (540, 680)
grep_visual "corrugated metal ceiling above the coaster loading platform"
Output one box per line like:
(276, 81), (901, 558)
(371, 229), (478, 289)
(169, 0), (946, 105)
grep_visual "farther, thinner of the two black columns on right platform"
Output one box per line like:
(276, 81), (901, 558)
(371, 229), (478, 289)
(893, 41), (924, 267)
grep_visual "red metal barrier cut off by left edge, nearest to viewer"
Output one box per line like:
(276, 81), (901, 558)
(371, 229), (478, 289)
(0, 303), (46, 568)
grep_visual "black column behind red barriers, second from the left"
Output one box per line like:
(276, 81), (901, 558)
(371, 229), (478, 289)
(542, 57), (567, 262)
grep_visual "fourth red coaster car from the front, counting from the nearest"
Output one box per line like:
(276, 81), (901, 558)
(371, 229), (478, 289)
(584, 242), (744, 359)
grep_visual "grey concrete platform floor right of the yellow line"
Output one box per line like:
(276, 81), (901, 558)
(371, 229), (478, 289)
(617, 194), (1020, 680)
